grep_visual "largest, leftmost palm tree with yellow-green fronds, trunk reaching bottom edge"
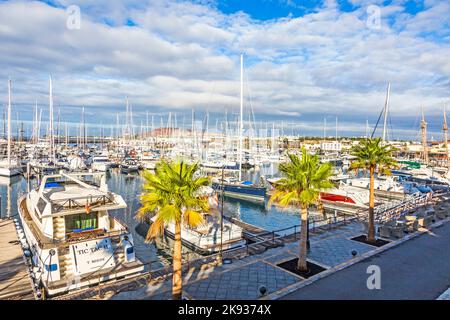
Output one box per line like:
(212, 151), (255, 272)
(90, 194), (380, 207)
(137, 160), (209, 300)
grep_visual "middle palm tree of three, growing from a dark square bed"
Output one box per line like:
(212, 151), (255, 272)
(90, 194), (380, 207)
(269, 147), (333, 272)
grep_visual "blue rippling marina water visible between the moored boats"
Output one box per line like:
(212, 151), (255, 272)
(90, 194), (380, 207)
(0, 165), (300, 268)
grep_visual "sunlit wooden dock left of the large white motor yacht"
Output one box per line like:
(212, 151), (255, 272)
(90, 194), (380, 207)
(0, 220), (34, 300)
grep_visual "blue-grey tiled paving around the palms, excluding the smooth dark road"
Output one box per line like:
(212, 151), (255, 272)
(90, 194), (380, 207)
(112, 222), (374, 300)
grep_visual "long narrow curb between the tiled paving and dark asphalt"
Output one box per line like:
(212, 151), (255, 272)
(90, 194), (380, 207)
(260, 217), (450, 300)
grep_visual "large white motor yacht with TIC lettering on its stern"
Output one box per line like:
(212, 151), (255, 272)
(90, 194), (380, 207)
(18, 172), (144, 296)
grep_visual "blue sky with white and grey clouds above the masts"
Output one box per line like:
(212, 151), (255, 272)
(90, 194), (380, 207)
(0, 0), (450, 140)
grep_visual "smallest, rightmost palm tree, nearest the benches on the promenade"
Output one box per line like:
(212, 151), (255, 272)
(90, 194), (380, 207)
(350, 138), (397, 243)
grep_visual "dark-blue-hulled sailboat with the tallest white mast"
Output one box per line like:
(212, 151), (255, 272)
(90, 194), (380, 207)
(212, 54), (266, 201)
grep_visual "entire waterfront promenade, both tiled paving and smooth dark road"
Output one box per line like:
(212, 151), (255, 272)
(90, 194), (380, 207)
(61, 196), (450, 300)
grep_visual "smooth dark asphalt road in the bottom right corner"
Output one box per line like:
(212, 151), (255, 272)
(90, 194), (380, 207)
(283, 218), (450, 300)
